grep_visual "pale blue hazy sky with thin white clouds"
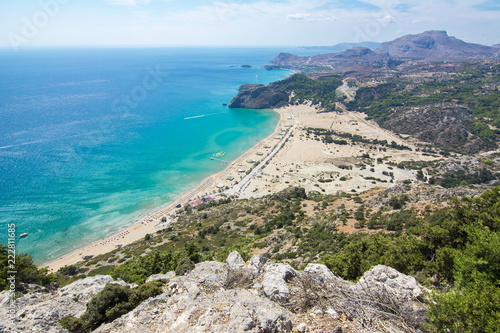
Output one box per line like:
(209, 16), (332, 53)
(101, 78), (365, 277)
(0, 0), (500, 50)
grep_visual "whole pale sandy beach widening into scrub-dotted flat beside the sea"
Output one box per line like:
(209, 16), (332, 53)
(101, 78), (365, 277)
(42, 105), (433, 271)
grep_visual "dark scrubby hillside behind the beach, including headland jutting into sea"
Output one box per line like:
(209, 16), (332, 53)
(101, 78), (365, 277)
(230, 63), (500, 154)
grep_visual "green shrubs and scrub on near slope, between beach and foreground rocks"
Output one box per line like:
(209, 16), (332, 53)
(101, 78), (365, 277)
(1, 183), (500, 332)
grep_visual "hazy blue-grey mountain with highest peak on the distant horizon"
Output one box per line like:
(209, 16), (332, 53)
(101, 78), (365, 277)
(375, 30), (499, 62)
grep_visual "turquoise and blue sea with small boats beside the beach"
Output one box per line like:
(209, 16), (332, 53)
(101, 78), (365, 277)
(0, 48), (296, 264)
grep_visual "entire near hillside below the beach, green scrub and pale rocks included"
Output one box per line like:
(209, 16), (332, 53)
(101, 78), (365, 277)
(0, 186), (500, 332)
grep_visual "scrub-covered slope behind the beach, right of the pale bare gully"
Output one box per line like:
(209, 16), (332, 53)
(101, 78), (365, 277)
(349, 63), (500, 152)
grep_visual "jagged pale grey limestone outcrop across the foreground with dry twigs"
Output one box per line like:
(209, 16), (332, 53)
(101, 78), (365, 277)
(0, 252), (425, 333)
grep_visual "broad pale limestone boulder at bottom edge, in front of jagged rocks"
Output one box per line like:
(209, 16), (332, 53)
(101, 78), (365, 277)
(94, 289), (292, 333)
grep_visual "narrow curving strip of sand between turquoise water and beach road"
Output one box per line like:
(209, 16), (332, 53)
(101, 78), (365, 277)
(42, 109), (292, 272)
